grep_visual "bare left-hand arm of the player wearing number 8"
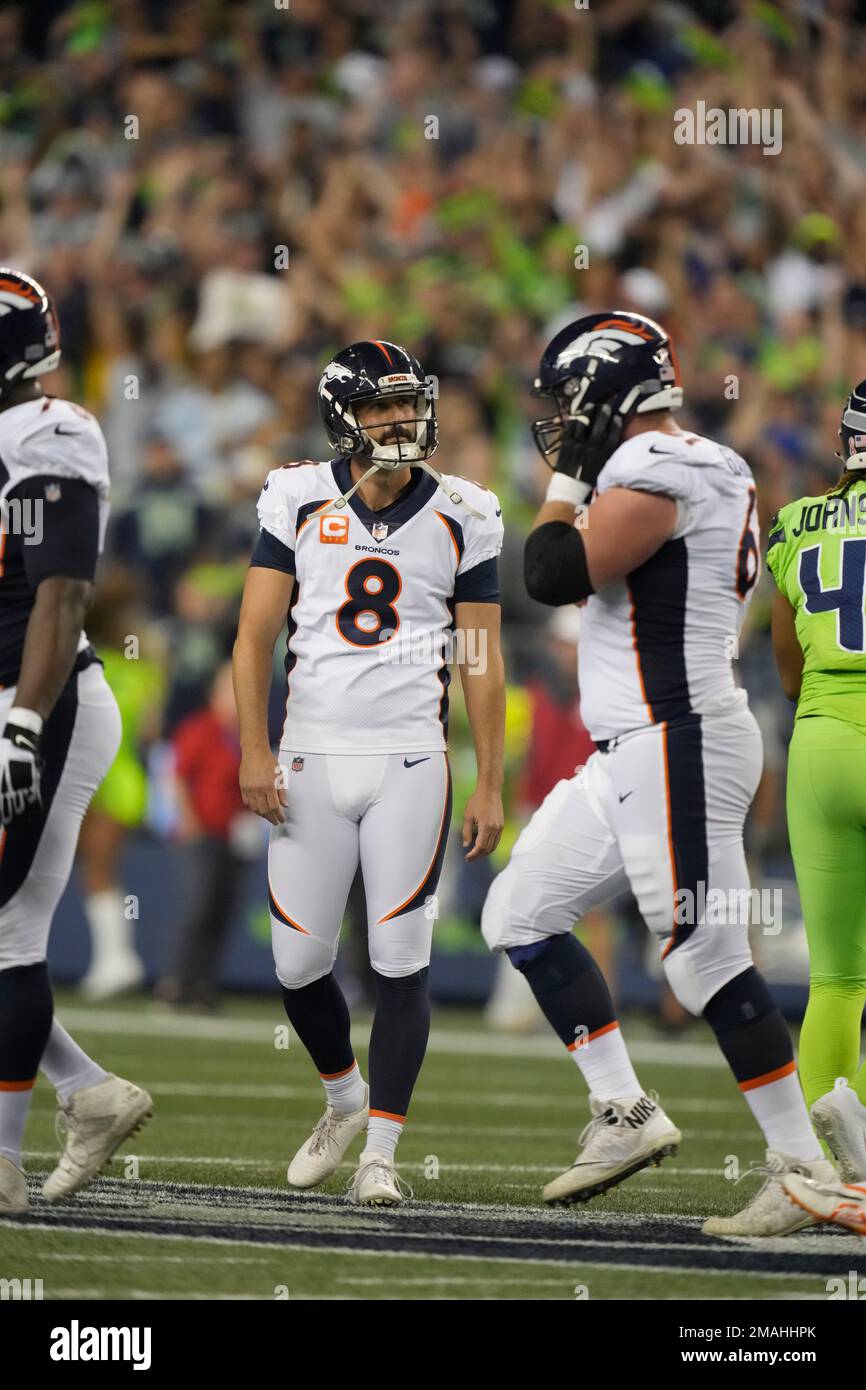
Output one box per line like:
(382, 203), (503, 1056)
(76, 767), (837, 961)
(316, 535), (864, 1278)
(232, 567), (295, 826)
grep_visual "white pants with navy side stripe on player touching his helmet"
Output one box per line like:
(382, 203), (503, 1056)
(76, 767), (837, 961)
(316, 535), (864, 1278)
(481, 709), (763, 1013)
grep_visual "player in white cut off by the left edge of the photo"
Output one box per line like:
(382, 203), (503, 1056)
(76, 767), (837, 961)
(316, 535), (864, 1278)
(0, 268), (152, 1212)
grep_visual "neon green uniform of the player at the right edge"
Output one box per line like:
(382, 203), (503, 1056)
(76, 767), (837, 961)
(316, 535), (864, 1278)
(767, 478), (866, 1105)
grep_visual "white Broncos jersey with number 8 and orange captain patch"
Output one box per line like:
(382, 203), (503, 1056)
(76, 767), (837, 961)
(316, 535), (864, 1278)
(252, 459), (503, 753)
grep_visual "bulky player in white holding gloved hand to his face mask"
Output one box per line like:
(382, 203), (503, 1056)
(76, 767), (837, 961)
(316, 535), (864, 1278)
(482, 311), (833, 1236)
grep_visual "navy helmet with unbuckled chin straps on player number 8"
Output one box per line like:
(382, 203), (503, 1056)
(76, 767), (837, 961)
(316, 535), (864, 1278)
(318, 339), (439, 468)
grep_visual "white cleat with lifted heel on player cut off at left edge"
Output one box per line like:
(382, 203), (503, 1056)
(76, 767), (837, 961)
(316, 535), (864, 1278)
(42, 1074), (153, 1202)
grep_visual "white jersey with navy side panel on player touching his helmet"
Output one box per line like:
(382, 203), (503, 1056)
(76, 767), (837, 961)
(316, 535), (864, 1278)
(580, 430), (760, 742)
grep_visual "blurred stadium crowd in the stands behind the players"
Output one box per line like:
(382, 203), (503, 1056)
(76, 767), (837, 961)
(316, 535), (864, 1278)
(0, 0), (866, 1006)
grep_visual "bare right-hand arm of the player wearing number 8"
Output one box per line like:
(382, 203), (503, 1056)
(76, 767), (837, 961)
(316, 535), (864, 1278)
(455, 603), (505, 860)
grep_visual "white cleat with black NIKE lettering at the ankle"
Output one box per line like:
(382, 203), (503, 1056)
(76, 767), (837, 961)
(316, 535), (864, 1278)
(541, 1093), (683, 1205)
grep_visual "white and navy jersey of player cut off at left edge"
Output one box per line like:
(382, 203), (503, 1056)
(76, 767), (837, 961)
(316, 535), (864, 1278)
(0, 396), (108, 685)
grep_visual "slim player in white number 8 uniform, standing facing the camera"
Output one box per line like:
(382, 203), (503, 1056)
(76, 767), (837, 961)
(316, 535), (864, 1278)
(235, 341), (505, 1204)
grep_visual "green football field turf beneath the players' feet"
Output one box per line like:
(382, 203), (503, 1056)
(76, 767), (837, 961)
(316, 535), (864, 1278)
(0, 994), (866, 1300)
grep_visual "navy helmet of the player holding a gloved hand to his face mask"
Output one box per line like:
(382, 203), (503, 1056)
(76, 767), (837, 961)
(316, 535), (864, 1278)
(532, 309), (683, 467)
